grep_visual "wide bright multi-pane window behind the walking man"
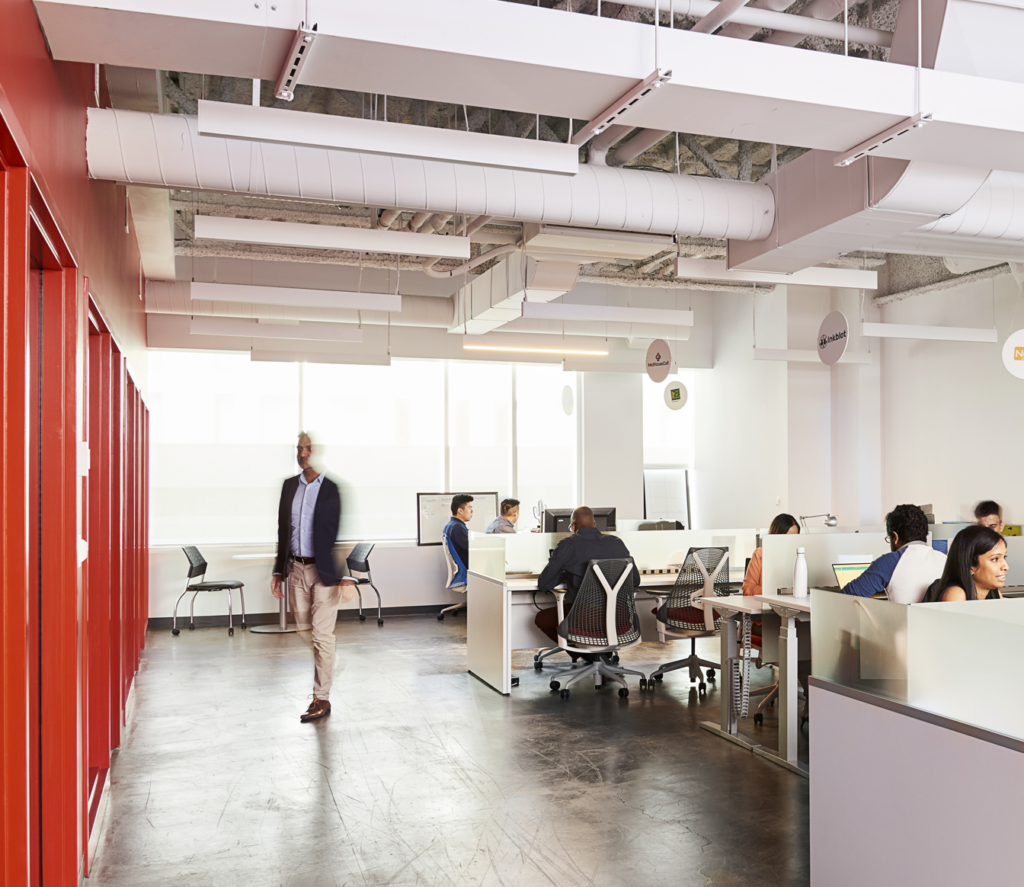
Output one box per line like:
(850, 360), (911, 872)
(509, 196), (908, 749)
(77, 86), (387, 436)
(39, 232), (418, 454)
(148, 351), (578, 544)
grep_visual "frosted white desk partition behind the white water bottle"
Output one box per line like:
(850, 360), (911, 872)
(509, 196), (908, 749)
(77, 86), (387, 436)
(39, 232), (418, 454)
(761, 533), (889, 594)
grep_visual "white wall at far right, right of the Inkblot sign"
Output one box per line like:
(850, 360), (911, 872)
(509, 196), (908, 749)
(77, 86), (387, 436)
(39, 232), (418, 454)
(882, 274), (1024, 523)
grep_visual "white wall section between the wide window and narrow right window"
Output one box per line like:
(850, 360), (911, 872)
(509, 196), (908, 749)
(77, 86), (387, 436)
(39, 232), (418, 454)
(580, 373), (643, 519)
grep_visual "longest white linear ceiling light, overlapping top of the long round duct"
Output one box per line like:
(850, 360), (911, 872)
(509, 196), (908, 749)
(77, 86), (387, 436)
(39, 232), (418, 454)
(199, 100), (580, 175)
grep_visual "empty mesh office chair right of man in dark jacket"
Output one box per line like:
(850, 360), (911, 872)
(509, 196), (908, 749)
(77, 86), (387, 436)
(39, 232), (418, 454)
(647, 548), (729, 693)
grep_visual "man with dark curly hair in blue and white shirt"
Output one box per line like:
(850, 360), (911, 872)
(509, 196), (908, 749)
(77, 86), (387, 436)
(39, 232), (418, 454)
(843, 505), (946, 603)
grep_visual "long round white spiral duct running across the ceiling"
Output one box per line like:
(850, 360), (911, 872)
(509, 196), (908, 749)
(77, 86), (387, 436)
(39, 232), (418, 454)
(87, 108), (775, 241)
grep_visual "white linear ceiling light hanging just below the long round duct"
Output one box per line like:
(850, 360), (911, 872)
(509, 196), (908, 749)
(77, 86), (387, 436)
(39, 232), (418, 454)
(196, 215), (469, 259)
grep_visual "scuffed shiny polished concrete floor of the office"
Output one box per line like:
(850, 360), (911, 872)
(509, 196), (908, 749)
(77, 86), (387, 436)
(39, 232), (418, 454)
(87, 617), (809, 887)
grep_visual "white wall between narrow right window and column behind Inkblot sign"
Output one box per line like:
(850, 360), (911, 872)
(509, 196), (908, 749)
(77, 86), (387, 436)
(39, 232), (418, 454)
(690, 287), (788, 527)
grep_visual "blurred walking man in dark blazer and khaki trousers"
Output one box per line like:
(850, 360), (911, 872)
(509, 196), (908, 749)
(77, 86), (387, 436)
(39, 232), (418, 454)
(270, 432), (354, 722)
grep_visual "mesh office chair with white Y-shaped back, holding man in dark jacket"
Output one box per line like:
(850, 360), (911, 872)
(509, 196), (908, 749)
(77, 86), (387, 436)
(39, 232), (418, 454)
(550, 557), (647, 700)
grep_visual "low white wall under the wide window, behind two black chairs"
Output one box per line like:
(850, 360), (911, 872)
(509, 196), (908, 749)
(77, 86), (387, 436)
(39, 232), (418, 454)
(150, 542), (454, 614)
